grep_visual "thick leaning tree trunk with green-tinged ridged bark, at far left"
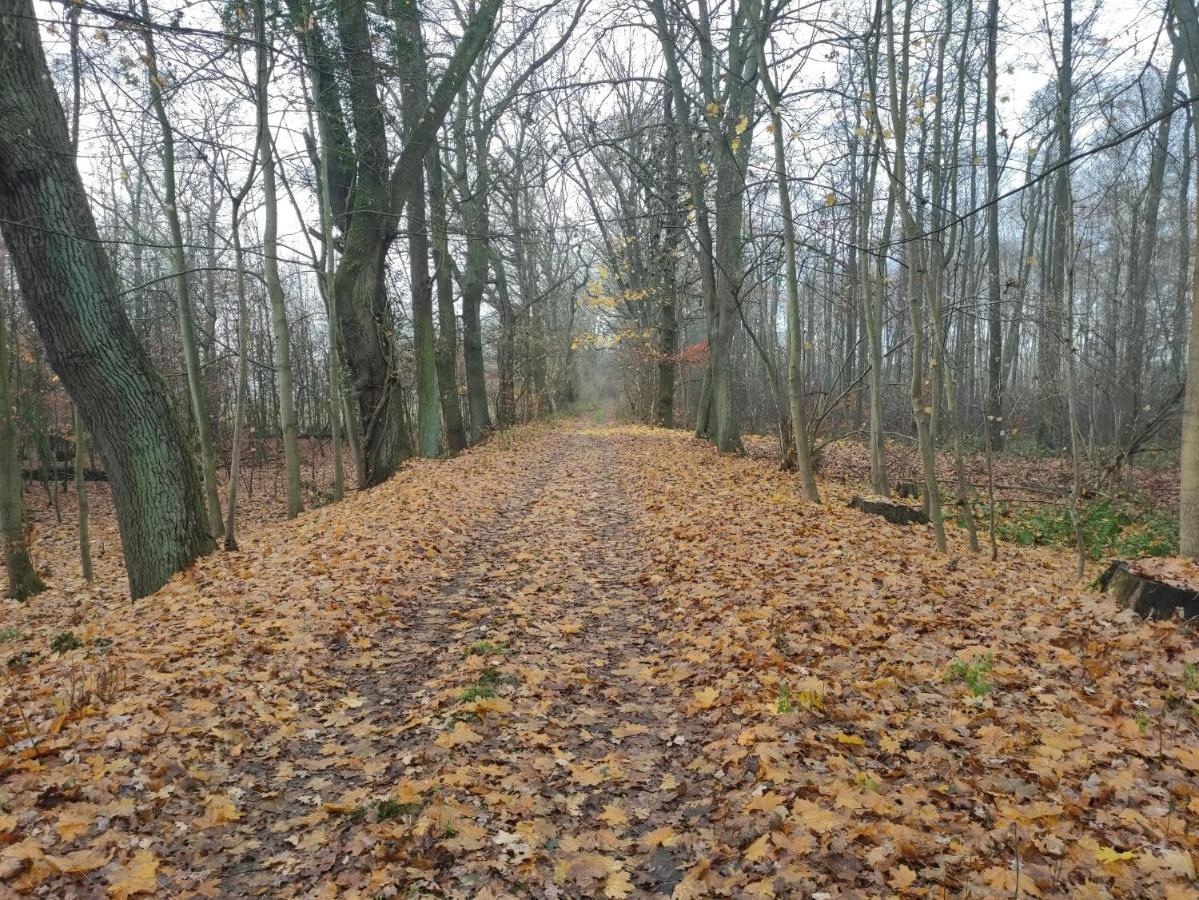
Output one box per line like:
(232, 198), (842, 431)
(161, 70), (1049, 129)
(0, 0), (212, 597)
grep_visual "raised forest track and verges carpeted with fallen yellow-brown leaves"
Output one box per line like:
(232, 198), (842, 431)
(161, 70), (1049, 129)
(0, 422), (1199, 898)
